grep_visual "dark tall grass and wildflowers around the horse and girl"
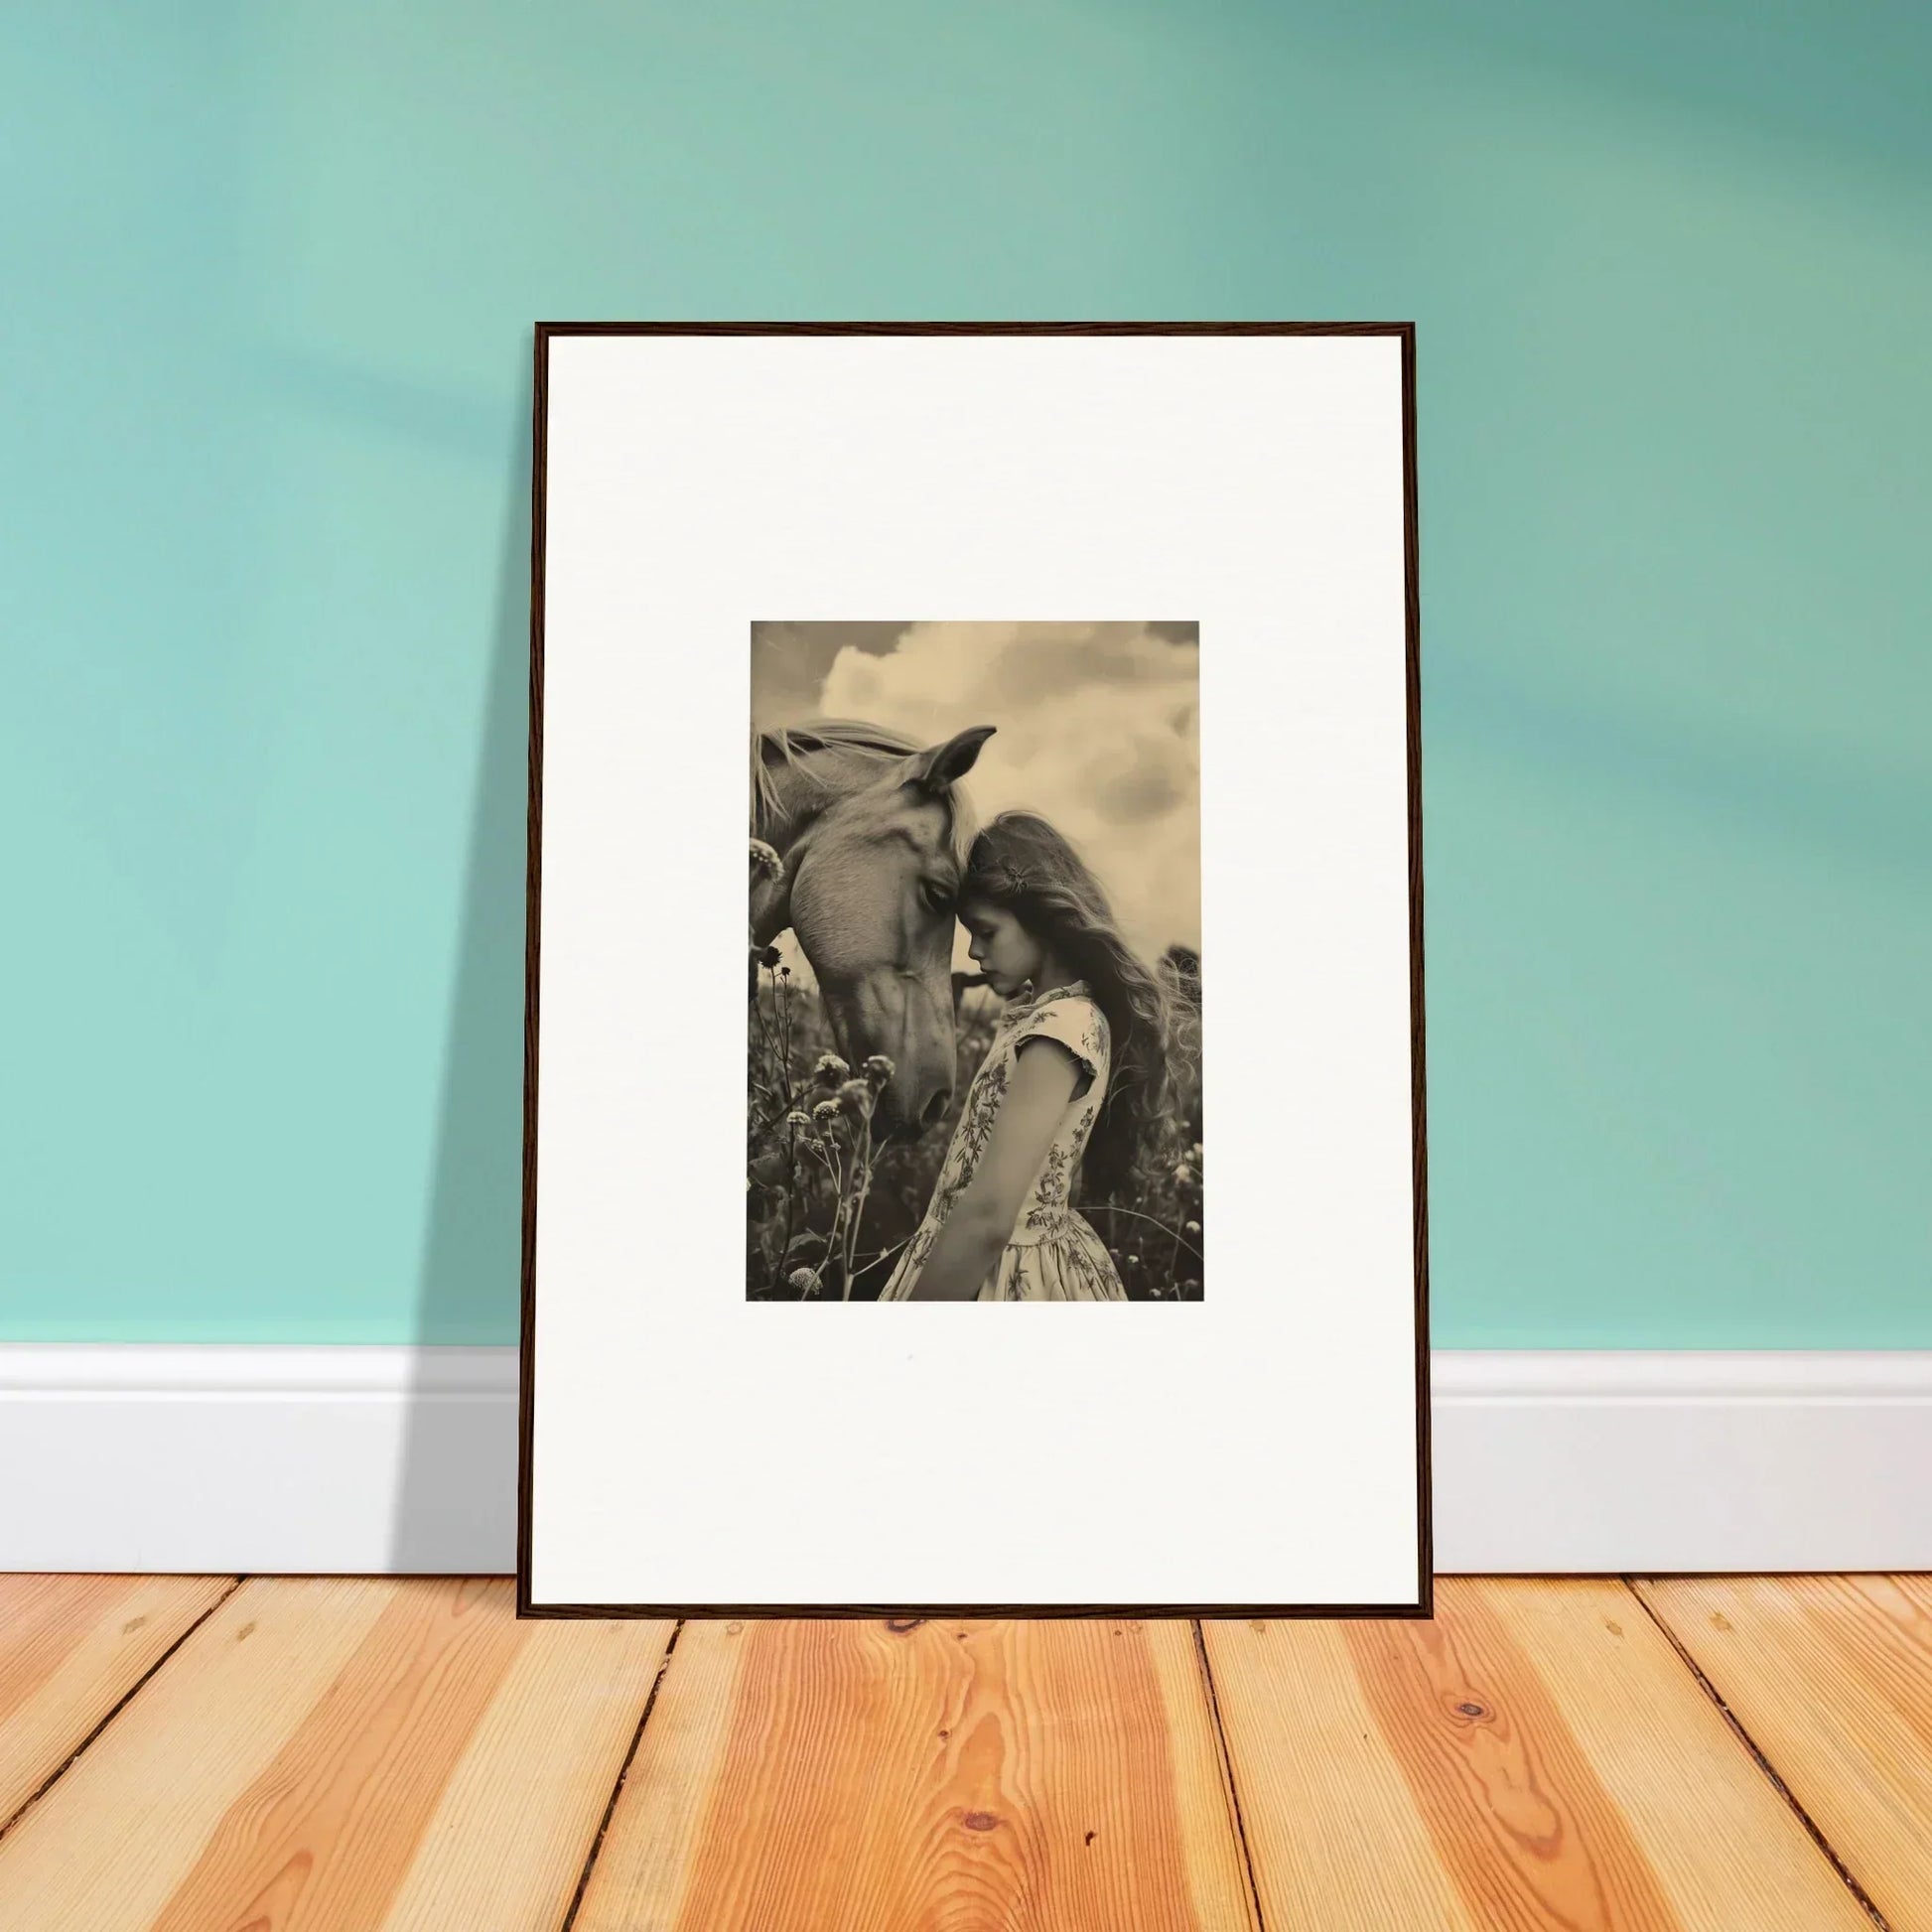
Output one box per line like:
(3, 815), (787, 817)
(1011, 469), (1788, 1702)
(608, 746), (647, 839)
(746, 947), (1203, 1301)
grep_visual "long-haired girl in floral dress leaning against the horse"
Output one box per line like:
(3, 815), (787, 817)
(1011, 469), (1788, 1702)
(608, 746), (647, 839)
(879, 811), (1167, 1303)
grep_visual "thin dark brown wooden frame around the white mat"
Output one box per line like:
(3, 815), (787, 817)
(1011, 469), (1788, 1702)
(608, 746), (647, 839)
(516, 323), (1434, 1619)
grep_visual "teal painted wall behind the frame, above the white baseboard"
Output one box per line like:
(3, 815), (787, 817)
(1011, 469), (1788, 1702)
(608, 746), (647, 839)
(0, 0), (1932, 1346)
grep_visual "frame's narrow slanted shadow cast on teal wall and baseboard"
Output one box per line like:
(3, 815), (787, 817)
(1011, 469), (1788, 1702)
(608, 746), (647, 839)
(388, 361), (531, 1573)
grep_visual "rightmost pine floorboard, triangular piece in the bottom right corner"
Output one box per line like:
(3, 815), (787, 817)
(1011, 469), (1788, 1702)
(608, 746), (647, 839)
(1636, 1577), (1932, 1932)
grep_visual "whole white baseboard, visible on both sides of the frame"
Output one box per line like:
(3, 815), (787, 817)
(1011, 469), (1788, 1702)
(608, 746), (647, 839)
(0, 1342), (1932, 1595)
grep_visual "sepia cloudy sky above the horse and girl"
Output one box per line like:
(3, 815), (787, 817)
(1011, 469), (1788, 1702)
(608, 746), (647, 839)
(752, 624), (1199, 960)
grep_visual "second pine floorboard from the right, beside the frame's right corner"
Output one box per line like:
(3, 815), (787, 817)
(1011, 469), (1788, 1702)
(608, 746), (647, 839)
(1203, 1579), (1870, 1932)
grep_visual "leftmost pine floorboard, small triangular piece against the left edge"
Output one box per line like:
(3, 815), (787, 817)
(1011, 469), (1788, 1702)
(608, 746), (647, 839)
(0, 1577), (233, 1828)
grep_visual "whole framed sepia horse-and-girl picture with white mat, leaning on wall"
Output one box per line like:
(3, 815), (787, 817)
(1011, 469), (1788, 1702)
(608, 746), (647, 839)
(518, 323), (1430, 1617)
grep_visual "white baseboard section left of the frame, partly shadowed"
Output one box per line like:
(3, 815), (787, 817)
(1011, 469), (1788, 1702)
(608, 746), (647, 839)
(0, 1342), (516, 1575)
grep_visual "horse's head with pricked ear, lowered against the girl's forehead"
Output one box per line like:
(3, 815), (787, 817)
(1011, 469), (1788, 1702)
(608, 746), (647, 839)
(788, 725), (993, 1136)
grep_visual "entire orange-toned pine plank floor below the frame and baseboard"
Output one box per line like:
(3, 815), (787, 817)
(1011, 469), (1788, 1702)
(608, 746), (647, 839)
(0, 1577), (1932, 1932)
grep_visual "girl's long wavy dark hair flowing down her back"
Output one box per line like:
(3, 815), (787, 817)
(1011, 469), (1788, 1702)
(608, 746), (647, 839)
(958, 811), (1173, 1198)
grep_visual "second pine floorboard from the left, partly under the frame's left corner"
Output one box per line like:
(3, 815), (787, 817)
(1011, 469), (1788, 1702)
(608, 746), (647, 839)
(0, 1579), (668, 1932)
